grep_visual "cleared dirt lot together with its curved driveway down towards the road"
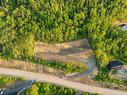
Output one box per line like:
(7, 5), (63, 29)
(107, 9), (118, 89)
(34, 39), (96, 80)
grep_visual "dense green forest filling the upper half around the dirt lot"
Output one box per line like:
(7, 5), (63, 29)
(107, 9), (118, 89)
(0, 0), (127, 66)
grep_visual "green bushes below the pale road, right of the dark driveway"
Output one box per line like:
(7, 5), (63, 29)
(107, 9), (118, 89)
(21, 82), (75, 95)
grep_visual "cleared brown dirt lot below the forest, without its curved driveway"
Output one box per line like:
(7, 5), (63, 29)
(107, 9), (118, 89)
(34, 39), (95, 61)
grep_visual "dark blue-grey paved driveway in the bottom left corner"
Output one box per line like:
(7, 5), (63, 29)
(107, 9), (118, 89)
(0, 80), (34, 95)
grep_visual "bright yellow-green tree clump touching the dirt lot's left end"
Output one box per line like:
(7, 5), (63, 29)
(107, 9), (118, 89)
(12, 34), (34, 58)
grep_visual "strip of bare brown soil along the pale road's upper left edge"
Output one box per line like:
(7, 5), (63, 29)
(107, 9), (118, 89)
(0, 59), (59, 75)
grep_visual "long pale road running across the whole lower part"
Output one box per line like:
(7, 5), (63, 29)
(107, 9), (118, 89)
(0, 67), (127, 95)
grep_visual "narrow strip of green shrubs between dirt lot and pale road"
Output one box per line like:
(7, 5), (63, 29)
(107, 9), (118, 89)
(18, 56), (87, 74)
